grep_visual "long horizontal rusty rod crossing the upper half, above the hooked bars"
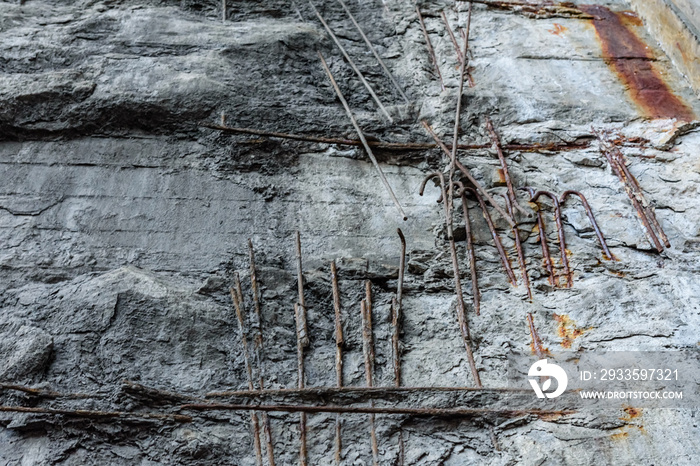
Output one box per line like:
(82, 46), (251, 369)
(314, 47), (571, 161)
(200, 123), (588, 152)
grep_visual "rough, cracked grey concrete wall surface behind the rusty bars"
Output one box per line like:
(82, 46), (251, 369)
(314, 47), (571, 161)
(0, 0), (700, 465)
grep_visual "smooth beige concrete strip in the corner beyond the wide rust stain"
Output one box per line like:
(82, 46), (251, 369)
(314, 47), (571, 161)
(630, 0), (700, 97)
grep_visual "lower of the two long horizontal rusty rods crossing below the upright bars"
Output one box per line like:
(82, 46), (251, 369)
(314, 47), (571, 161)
(178, 403), (576, 417)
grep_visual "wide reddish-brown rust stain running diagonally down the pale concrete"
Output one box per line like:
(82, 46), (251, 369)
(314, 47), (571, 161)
(580, 5), (695, 121)
